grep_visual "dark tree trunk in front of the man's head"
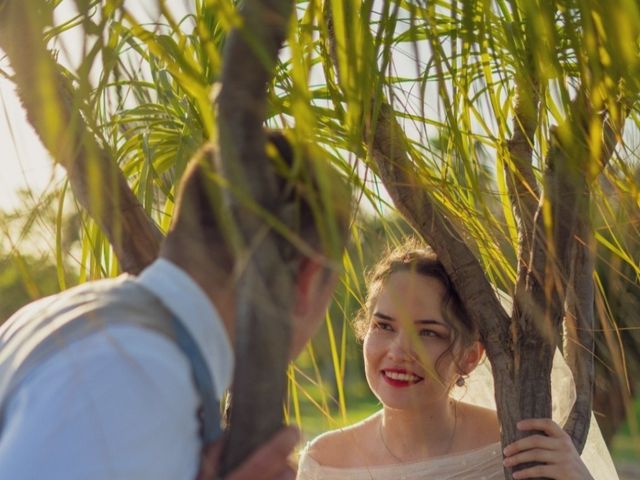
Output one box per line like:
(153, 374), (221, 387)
(218, 0), (295, 475)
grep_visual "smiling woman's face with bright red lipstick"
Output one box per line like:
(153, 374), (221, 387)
(363, 272), (457, 409)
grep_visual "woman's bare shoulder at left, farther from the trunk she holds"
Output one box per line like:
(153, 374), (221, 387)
(306, 414), (377, 468)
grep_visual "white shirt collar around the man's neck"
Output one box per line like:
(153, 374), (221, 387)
(137, 258), (234, 399)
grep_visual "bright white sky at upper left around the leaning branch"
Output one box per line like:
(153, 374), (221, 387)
(0, 0), (193, 212)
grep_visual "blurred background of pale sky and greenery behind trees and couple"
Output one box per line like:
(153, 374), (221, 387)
(0, 0), (640, 479)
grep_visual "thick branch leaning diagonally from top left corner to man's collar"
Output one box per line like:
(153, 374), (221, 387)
(0, 0), (162, 273)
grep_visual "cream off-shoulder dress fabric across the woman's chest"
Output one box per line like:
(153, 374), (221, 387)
(297, 443), (504, 480)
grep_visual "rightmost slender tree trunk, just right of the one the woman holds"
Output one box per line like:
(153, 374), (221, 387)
(532, 91), (620, 452)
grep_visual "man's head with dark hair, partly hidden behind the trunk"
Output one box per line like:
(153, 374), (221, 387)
(163, 130), (351, 354)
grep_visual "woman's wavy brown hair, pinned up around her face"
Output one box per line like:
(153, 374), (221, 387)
(353, 237), (478, 376)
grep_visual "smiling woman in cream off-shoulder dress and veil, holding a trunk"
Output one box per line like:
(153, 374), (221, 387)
(297, 244), (617, 480)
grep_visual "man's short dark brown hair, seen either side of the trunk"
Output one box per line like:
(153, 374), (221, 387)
(167, 130), (351, 271)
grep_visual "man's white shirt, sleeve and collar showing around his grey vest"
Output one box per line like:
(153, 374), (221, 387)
(0, 259), (233, 480)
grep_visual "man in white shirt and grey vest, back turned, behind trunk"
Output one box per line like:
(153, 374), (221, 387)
(0, 132), (349, 480)
